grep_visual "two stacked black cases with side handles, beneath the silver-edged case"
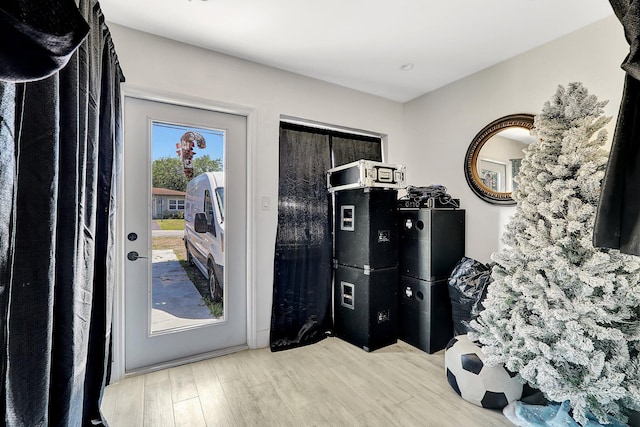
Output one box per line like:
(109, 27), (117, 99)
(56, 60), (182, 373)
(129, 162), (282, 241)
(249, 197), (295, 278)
(334, 187), (398, 351)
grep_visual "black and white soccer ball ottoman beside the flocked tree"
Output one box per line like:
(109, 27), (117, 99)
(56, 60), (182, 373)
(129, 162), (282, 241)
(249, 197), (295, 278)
(444, 335), (522, 409)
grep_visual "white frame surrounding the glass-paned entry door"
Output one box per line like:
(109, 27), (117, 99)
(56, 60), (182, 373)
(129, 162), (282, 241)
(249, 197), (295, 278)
(111, 83), (257, 382)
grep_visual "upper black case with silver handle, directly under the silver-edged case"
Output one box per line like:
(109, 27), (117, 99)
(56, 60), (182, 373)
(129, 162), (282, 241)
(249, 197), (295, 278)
(334, 187), (398, 269)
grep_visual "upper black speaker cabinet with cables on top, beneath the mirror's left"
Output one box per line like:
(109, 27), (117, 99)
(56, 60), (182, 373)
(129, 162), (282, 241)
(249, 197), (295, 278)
(398, 209), (465, 280)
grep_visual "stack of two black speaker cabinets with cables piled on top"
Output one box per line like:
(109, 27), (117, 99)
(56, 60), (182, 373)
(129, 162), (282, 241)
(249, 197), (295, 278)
(398, 208), (465, 353)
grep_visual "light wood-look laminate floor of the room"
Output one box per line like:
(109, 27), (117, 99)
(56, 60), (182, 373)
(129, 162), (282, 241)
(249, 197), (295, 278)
(102, 338), (512, 427)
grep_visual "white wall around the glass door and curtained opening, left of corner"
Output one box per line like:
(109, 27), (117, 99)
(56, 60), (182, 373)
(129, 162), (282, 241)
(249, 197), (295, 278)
(109, 23), (404, 347)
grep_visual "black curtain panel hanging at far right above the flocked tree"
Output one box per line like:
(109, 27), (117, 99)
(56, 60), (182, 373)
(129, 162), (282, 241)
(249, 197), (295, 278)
(593, 0), (640, 255)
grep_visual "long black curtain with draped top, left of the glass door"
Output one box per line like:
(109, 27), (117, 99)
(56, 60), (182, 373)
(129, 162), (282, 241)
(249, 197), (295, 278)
(0, 0), (124, 426)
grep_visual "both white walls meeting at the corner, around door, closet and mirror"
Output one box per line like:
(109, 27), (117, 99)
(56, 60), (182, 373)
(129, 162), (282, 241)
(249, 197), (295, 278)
(109, 17), (628, 347)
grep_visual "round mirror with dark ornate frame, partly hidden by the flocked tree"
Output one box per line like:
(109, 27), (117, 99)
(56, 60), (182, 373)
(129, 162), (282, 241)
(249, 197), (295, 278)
(464, 114), (536, 205)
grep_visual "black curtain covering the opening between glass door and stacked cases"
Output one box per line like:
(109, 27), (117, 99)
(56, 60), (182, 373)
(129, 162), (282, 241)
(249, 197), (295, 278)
(271, 123), (382, 351)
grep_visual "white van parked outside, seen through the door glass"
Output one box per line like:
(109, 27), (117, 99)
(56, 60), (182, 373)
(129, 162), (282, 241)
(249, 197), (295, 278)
(184, 172), (224, 302)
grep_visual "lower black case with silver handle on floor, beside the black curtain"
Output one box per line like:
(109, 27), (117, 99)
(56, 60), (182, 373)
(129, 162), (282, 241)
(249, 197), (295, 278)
(334, 264), (398, 351)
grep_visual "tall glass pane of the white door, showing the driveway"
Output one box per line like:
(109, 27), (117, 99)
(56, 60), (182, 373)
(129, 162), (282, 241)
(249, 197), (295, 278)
(149, 121), (225, 334)
